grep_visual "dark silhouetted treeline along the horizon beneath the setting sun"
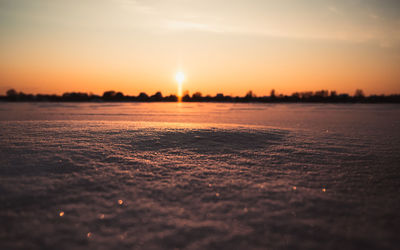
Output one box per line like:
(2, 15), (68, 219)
(0, 89), (400, 103)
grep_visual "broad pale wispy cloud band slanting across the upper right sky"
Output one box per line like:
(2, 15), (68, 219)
(114, 0), (400, 47)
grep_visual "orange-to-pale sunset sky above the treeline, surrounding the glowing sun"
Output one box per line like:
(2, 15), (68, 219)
(0, 0), (400, 95)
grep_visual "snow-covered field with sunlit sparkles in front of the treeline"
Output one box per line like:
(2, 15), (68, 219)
(0, 103), (400, 249)
